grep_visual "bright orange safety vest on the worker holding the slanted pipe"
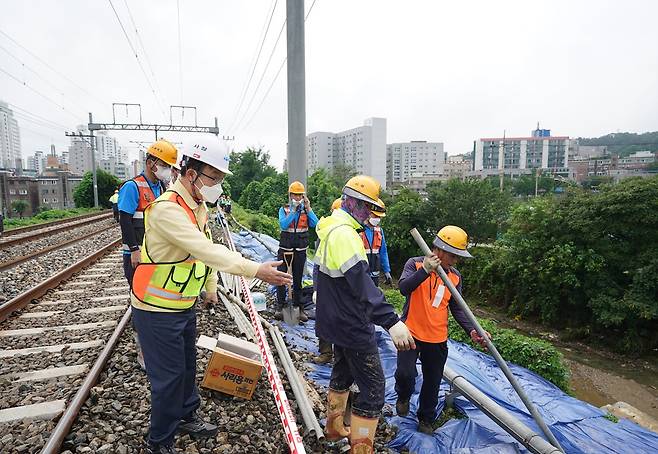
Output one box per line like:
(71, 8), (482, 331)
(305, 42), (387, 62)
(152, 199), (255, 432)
(404, 262), (460, 343)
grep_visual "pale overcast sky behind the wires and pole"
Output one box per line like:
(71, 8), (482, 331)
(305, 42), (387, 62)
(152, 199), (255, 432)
(0, 0), (658, 167)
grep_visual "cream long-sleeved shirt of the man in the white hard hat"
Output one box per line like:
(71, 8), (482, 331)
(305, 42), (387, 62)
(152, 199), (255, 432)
(131, 181), (260, 312)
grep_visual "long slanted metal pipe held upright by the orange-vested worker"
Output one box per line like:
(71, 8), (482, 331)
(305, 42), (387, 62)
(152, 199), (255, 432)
(411, 228), (564, 452)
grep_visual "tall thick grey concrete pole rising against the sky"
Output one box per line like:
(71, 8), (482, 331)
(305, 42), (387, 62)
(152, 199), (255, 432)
(286, 0), (306, 185)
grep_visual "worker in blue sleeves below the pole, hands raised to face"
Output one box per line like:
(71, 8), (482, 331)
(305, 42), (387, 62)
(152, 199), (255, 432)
(274, 181), (318, 322)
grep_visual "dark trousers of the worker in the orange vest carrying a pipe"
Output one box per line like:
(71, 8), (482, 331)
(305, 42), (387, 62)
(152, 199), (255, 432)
(395, 339), (448, 423)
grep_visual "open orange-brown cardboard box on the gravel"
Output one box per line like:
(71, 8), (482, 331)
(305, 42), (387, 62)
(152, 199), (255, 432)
(197, 334), (263, 399)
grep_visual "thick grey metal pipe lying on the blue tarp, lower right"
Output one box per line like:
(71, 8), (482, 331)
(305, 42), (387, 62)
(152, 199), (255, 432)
(443, 366), (561, 454)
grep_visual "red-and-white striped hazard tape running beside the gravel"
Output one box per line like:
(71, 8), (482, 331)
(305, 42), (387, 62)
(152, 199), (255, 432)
(222, 214), (306, 454)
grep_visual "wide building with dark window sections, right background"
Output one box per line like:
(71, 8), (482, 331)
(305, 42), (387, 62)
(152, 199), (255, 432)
(471, 130), (570, 177)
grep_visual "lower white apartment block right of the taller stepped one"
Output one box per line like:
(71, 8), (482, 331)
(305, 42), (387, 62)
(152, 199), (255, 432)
(386, 140), (446, 186)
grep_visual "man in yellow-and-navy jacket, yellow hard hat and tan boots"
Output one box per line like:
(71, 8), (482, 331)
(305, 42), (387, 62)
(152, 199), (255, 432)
(315, 175), (414, 454)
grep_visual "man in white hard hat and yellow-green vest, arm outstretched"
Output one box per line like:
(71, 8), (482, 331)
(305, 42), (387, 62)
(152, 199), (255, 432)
(131, 137), (291, 454)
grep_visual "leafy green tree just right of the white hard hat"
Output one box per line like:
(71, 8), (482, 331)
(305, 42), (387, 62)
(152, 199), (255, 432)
(226, 147), (277, 200)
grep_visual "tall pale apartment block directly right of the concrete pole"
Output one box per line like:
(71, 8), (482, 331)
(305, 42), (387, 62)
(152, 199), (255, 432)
(306, 117), (386, 189)
